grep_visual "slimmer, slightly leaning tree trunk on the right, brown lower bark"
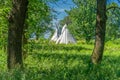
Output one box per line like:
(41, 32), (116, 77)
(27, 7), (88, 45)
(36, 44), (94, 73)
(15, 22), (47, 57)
(92, 0), (107, 64)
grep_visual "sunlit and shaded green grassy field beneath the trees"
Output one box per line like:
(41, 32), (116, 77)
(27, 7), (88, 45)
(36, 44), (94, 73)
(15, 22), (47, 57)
(0, 41), (120, 80)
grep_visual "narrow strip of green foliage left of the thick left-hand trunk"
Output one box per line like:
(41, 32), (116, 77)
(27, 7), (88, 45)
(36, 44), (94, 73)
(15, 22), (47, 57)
(0, 0), (11, 48)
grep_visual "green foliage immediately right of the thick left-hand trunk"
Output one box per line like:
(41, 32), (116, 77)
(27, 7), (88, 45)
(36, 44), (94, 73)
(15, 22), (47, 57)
(26, 0), (51, 37)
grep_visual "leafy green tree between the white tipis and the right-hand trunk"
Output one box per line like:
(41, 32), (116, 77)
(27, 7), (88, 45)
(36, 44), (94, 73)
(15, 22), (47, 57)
(62, 0), (96, 43)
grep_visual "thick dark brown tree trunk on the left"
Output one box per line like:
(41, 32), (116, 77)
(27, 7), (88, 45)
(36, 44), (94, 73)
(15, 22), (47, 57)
(7, 0), (28, 69)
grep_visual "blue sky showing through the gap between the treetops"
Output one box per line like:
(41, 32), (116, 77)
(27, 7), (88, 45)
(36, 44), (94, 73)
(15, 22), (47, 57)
(49, 0), (118, 22)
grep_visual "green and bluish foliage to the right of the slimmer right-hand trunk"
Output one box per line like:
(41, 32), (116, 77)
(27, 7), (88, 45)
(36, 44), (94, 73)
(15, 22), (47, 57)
(106, 3), (120, 40)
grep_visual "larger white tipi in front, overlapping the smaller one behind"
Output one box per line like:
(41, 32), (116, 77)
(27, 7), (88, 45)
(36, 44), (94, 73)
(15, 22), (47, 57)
(56, 24), (76, 44)
